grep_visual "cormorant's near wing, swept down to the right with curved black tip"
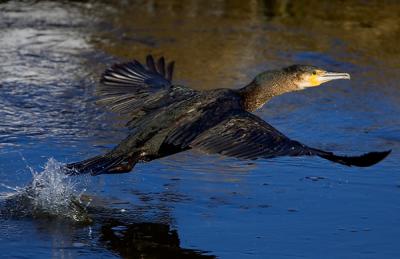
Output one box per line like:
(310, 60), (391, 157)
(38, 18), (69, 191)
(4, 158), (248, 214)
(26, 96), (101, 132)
(190, 112), (390, 167)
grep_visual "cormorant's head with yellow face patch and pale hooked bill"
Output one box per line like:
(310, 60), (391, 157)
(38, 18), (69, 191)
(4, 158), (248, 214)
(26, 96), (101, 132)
(283, 65), (350, 90)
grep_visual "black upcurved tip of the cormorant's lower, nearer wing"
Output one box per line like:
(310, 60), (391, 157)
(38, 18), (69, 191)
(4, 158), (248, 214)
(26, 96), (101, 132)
(311, 148), (391, 167)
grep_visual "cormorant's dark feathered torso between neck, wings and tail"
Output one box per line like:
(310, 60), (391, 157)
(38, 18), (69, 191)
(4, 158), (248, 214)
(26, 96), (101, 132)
(109, 86), (241, 165)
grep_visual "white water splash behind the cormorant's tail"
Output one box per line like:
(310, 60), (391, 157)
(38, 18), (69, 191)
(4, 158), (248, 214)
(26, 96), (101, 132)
(0, 158), (91, 223)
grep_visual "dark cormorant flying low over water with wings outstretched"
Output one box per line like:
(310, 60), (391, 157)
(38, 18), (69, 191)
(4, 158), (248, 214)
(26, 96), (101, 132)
(66, 55), (391, 175)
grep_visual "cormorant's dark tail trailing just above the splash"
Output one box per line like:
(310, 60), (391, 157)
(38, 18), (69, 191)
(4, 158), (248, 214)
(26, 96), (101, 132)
(65, 152), (138, 175)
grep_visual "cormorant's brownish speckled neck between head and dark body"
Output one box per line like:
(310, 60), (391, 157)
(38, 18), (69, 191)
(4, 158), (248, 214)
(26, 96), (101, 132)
(239, 71), (294, 112)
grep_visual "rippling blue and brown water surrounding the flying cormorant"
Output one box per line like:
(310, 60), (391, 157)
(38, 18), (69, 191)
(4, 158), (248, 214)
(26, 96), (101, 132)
(0, 0), (400, 258)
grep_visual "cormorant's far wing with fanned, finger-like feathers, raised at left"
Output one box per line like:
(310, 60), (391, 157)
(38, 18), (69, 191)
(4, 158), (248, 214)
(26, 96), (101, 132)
(97, 55), (190, 114)
